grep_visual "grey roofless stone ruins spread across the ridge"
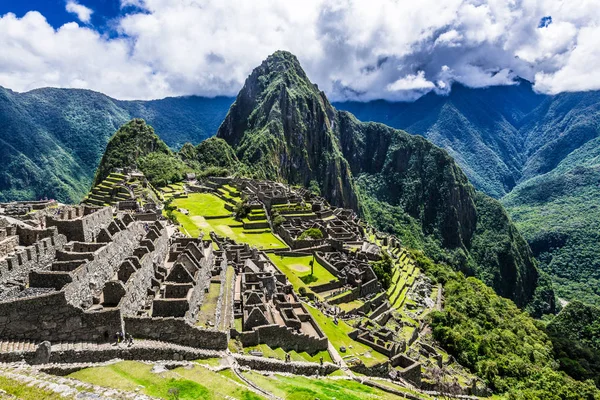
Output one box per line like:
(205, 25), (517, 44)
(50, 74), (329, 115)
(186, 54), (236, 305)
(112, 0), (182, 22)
(0, 178), (482, 396)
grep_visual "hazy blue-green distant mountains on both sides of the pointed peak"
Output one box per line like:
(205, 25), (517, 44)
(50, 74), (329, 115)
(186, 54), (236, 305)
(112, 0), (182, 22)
(0, 65), (600, 304)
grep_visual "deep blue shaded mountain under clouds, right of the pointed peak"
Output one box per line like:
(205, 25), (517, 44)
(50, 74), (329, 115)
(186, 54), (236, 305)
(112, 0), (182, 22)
(335, 81), (547, 198)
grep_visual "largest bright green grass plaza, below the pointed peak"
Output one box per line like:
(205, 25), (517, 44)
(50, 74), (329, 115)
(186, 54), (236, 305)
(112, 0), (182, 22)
(172, 193), (287, 250)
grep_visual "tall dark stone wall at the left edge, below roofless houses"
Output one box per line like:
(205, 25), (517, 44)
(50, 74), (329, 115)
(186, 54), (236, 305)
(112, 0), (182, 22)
(0, 291), (122, 342)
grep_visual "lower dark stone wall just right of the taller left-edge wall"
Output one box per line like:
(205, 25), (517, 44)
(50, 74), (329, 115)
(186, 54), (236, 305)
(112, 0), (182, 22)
(125, 317), (229, 350)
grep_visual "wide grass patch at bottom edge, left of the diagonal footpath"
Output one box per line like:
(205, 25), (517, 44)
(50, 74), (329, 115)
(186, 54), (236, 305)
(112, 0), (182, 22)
(69, 361), (261, 400)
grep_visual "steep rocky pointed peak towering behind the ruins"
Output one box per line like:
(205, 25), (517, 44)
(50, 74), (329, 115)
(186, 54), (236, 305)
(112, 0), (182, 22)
(217, 51), (358, 208)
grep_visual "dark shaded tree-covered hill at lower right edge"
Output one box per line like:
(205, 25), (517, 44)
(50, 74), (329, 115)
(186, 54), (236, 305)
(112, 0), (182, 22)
(547, 301), (600, 387)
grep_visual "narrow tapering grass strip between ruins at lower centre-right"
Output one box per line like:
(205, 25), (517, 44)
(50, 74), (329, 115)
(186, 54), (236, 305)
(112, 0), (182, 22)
(306, 304), (388, 365)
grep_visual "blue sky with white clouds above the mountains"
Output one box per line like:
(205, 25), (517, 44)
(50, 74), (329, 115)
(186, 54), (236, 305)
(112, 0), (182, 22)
(0, 0), (600, 101)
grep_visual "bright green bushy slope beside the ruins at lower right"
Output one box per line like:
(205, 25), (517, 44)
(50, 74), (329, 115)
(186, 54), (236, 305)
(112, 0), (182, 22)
(417, 254), (600, 399)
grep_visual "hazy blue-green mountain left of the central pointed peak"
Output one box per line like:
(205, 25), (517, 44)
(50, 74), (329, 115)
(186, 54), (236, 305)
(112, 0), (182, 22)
(0, 87), (232, 202)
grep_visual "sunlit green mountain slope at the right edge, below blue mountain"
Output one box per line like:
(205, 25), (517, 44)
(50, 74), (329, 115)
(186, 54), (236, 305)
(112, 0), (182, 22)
(503, 138), (600, 304)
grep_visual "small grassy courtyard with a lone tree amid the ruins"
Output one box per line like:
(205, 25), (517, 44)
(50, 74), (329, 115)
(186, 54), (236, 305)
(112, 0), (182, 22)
(269, 254), (337, 292)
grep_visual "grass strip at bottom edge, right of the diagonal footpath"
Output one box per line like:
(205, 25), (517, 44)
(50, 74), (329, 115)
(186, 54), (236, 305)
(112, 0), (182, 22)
(244, 371), (406, 400)
